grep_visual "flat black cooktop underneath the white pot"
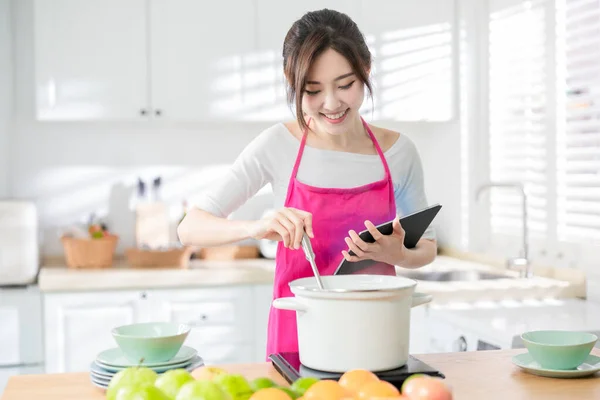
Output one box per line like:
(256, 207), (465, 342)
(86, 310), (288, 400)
(269, 352), (446, 389)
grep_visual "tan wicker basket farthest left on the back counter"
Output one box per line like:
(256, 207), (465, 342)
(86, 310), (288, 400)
(61, 235), (119, 268)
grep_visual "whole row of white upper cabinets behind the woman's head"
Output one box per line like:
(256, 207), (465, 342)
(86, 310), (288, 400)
(30, 0), (457, 122)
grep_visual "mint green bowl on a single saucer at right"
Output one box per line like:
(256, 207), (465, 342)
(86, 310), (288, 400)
(521, 330), (598, 370)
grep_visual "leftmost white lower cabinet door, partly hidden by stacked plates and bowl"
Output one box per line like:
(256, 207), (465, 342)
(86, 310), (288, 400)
(44, 291), (145, 373)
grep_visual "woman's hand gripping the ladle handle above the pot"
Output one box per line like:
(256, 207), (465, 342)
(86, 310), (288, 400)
(250, 207), (314, 250)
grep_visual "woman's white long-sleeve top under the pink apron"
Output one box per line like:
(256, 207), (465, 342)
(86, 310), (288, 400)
(195, 123), (435, 239)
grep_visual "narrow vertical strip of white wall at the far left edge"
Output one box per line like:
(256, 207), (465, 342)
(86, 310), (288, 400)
(0, 0), (13, 198)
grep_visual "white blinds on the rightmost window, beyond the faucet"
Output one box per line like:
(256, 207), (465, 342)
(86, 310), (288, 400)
(556, 0), (600, 242)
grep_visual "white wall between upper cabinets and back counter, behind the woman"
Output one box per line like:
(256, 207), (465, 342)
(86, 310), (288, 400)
(9, 0), (461, 254)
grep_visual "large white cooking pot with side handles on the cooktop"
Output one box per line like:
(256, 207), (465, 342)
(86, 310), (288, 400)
(273, 275), (432, 373)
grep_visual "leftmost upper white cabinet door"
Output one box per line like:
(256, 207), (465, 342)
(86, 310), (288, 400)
(34, 0), (148, 120)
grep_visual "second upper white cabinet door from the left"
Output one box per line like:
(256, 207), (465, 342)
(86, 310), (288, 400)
(150, 0), (259, 121)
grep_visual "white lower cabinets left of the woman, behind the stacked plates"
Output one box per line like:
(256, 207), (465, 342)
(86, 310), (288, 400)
(44, 285), (272, 372)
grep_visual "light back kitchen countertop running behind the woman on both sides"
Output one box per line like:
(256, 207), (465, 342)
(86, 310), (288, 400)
(38, 255), (585, 303)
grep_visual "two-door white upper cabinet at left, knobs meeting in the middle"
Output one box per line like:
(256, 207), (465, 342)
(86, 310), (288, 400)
(34, 0), (256, 121)
